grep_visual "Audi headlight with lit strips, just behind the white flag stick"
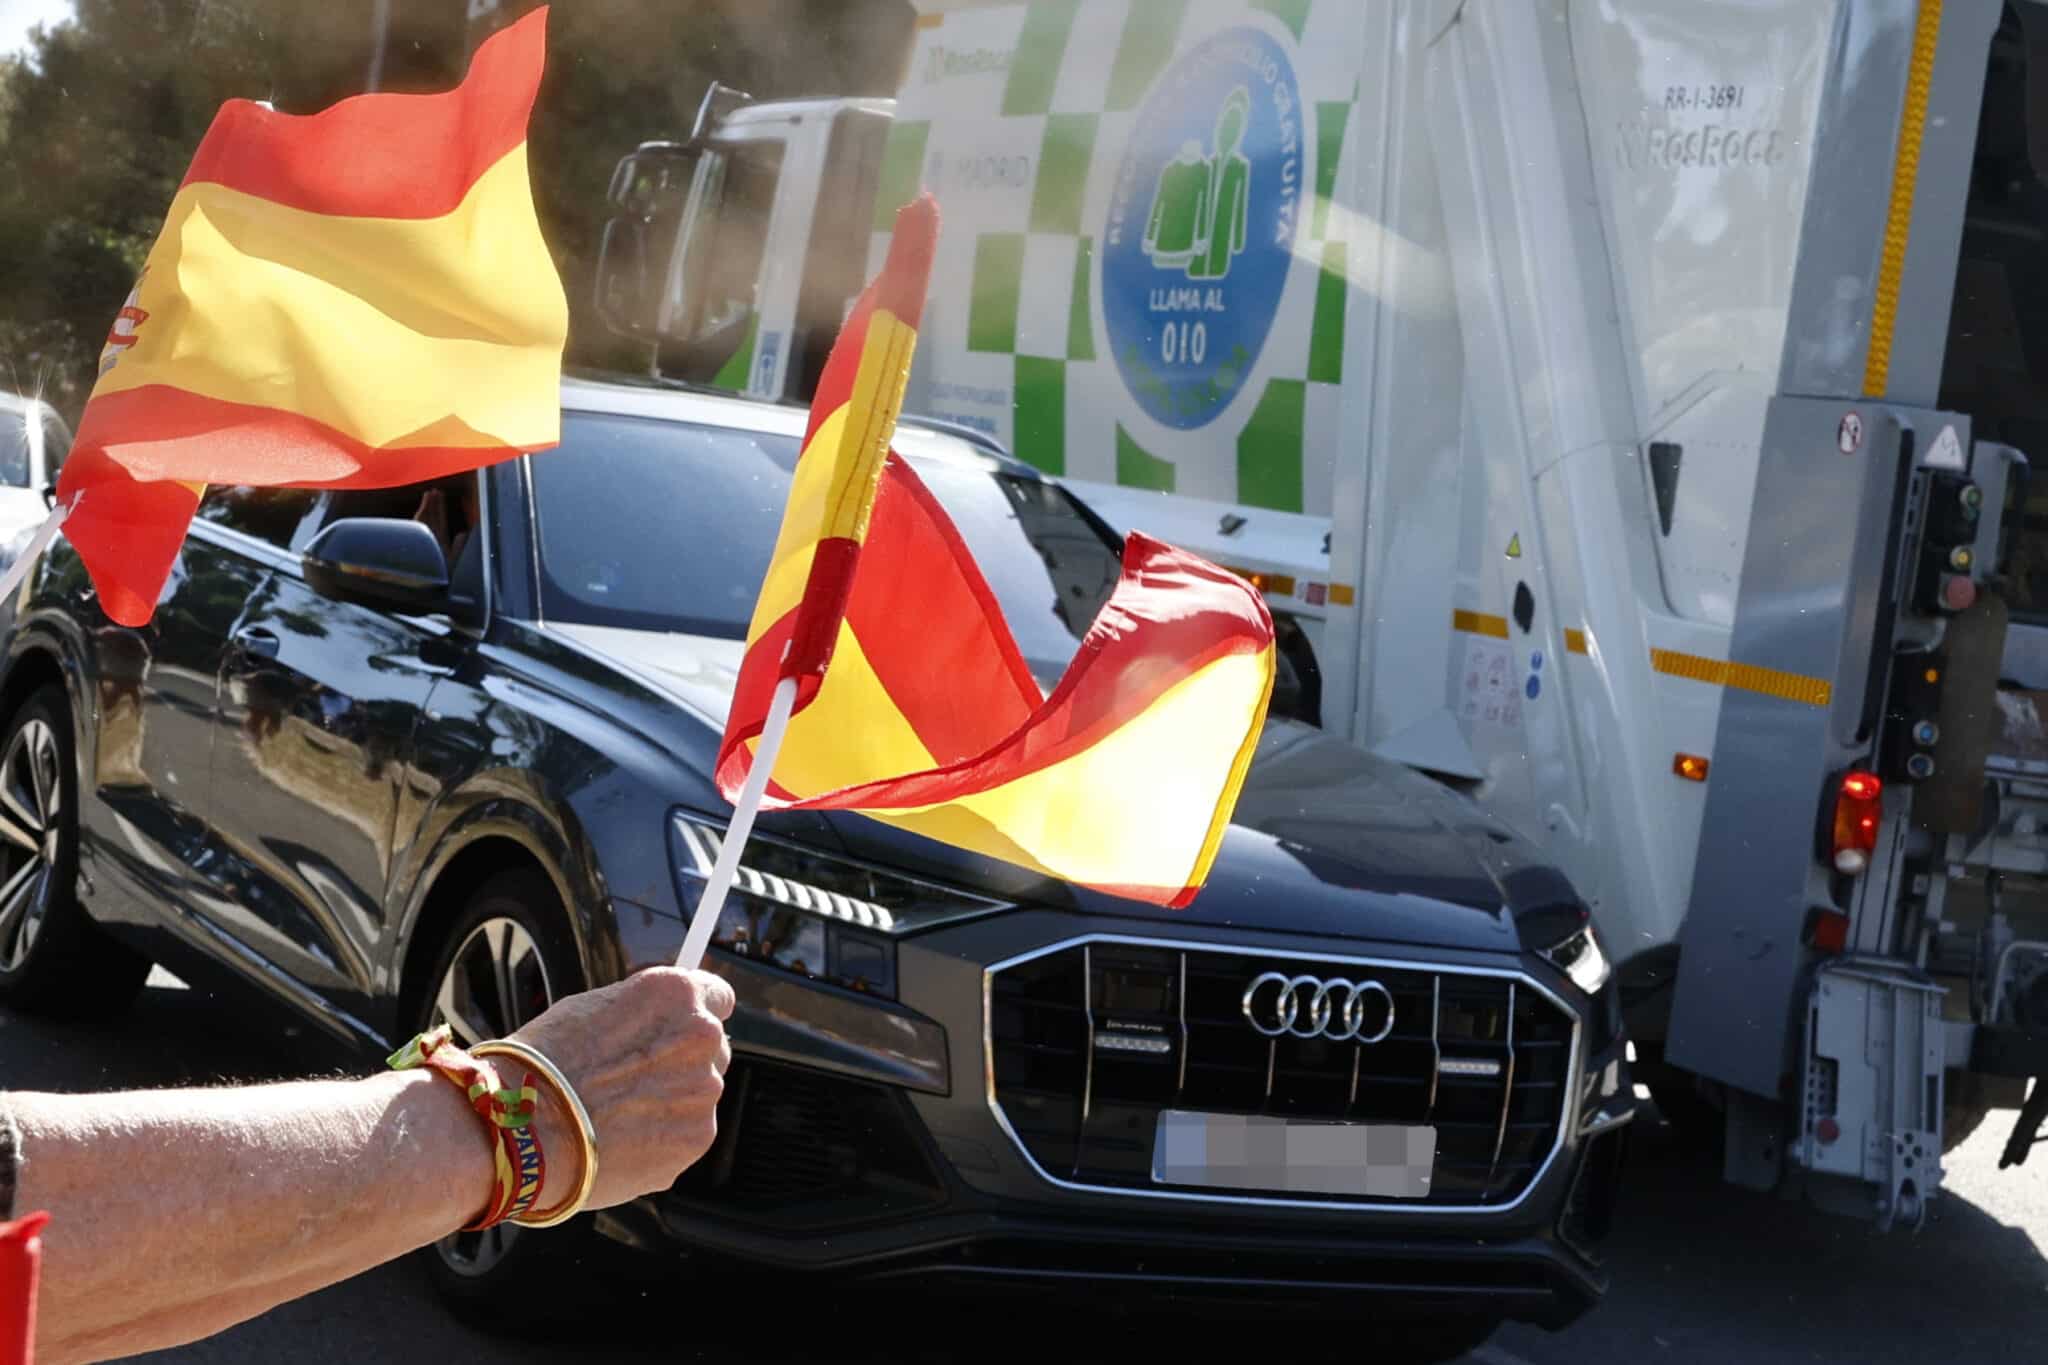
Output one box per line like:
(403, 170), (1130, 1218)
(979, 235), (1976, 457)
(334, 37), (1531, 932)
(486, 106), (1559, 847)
(668, 810), (1012, 999)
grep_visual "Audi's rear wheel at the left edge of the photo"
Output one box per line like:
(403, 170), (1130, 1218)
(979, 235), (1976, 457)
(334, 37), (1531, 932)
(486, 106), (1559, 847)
(0, 684), (150, 1019)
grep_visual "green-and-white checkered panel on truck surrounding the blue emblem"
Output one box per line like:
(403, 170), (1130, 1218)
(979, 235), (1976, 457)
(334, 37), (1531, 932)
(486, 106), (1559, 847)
(870, 0), (1366, 512)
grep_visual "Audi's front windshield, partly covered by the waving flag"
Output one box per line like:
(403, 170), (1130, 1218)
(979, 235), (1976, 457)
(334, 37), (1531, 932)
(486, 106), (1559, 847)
(532, 411), (1120, 686)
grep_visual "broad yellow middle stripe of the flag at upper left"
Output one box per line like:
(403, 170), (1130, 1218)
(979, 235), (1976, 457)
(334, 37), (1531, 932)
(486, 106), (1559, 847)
(94, 145), (567, 458)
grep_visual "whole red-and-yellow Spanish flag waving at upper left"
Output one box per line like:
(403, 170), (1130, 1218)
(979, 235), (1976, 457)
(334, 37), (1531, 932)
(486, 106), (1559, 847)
(57, 8), (569, 626)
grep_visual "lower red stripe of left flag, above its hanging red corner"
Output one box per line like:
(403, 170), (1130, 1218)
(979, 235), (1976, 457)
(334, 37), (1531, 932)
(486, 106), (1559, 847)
(57, 385), (557, 499)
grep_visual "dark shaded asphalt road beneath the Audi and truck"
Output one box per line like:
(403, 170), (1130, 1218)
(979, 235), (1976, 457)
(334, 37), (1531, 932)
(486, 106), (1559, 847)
(0, 974), (2048, 1365)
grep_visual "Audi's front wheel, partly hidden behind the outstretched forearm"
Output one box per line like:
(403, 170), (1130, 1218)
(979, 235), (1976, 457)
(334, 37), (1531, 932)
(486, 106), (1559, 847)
(406, 868), (610, 1332)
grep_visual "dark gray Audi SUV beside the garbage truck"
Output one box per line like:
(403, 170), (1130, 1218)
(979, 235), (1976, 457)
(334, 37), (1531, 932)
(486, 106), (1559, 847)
(0, 379), (1632, 1358)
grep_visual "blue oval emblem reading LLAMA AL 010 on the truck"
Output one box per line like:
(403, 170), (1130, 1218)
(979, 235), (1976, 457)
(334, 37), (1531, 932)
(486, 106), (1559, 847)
(1102, 27), (1305, 430)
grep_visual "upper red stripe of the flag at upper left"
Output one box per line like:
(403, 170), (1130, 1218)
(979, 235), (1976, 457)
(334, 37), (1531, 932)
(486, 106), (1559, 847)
(180, 6), (547, 219)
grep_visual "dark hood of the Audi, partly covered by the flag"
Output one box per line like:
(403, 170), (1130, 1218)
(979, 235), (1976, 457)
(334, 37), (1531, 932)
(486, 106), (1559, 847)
(547, 624), (1577, 950)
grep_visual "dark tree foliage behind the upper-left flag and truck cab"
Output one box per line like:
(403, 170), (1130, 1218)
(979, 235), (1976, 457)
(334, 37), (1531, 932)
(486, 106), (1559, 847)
(0, 0), (913, 420)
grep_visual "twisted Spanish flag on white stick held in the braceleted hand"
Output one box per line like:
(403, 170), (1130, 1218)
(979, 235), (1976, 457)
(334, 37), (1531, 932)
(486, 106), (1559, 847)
(717, 194), (1274, 907)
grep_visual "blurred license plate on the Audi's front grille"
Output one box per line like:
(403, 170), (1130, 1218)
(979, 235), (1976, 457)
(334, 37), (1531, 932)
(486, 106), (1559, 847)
(1153, 1109), (1436, 1199)
